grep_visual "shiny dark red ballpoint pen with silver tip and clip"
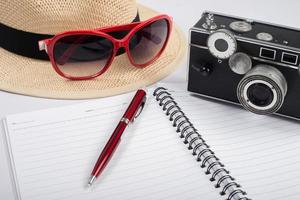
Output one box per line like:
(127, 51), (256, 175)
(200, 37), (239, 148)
(88, 90), (146, 186)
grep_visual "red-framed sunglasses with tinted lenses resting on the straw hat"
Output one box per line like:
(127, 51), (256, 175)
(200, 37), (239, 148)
(39, 15), (172, 80)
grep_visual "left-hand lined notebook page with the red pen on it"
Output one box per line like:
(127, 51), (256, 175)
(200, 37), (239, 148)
(5, 92), (220, 200)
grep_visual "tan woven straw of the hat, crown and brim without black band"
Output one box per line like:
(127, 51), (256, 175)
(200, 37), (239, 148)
(0, 0), (187, 99)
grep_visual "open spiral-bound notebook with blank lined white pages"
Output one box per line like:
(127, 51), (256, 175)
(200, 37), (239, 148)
(4, 84), (300, 200)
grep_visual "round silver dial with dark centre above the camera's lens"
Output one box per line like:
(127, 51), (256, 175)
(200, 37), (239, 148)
(207, 29), (237, 59)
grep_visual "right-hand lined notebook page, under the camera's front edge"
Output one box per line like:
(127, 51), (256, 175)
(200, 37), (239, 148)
(166, 86), (300, 200)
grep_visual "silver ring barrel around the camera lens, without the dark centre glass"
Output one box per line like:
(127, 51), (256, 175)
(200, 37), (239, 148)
(237, 65), (287, 115)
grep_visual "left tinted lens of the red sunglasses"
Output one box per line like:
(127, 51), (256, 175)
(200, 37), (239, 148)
(53, 35), (113, 78)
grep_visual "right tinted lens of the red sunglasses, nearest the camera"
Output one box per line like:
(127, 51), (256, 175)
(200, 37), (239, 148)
(129, 19), (169, 65)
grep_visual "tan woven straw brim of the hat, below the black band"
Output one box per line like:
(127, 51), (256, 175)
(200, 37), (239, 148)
(0, 5), (187, 99)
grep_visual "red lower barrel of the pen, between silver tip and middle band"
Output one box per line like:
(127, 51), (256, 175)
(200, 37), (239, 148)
(91, 122), (127, 177)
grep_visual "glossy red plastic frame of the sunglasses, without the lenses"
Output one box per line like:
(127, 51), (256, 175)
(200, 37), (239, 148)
(39, 15), (173, 80)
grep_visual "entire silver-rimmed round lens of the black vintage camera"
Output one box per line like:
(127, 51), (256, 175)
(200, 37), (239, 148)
(237, 65), (287, 115)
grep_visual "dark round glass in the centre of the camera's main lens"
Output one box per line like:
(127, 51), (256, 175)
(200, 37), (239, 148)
(247, 83), (274, 107)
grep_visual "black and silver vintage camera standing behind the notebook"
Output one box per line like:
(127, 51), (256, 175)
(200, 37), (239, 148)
(188, 12), (300, 120)
